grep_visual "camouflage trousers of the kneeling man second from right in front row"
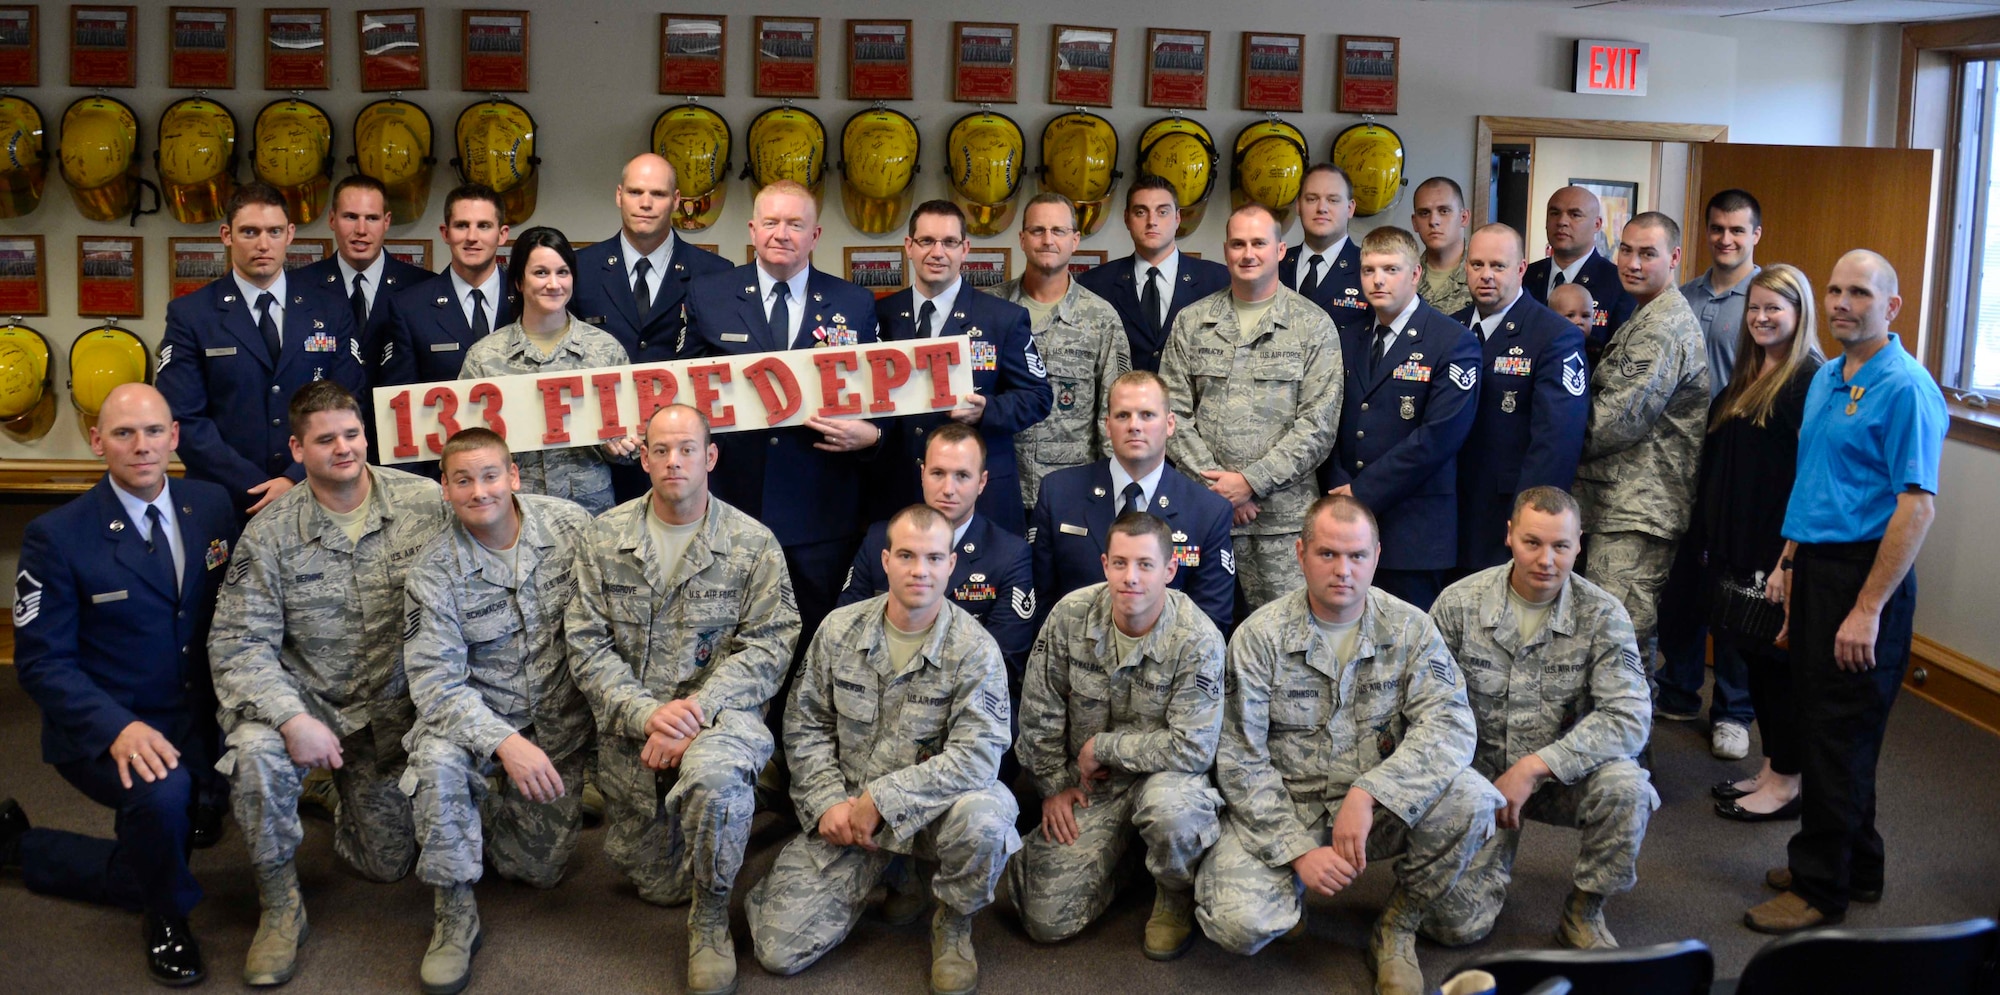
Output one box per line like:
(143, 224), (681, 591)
(1194, 769), (1504, 955)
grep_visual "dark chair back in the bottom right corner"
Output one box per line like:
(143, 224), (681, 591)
(1736, 919), (2000, 995)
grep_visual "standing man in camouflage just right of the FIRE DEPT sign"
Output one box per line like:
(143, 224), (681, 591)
(992, 192), (1132, 507)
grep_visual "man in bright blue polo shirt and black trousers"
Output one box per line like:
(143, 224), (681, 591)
(1744, 250), (1948, 933)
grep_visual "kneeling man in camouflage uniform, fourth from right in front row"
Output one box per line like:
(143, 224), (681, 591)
(744, 505), (1020, 995)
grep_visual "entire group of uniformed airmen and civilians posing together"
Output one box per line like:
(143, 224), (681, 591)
(0, 145), (1944, 995)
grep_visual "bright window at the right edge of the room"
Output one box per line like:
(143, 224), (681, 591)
(1940, 58), (2000, 396)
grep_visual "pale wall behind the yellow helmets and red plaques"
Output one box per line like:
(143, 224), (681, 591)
(0, 0), (1904, 575)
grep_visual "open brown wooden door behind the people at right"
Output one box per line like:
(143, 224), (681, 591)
(1686, 142), (1938, 358)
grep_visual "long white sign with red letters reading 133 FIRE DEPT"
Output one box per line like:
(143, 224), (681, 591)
(374, 336), (972, 464)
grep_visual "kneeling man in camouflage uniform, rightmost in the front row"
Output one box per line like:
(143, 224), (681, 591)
(1424, 488), (1660, 947)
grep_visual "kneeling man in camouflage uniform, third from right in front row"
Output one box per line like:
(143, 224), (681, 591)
(1008, 539), (1224, 961)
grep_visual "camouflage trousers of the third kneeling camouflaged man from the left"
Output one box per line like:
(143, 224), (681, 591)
(598, 709), (772, 905)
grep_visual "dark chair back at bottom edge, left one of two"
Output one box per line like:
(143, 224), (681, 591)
(1452, 939), (1716, 995)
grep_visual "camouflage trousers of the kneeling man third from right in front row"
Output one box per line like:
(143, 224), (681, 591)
(1006, 771), (1222, 943)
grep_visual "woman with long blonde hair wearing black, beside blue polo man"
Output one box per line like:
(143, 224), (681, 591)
(1694, 264), (1826, 821)
